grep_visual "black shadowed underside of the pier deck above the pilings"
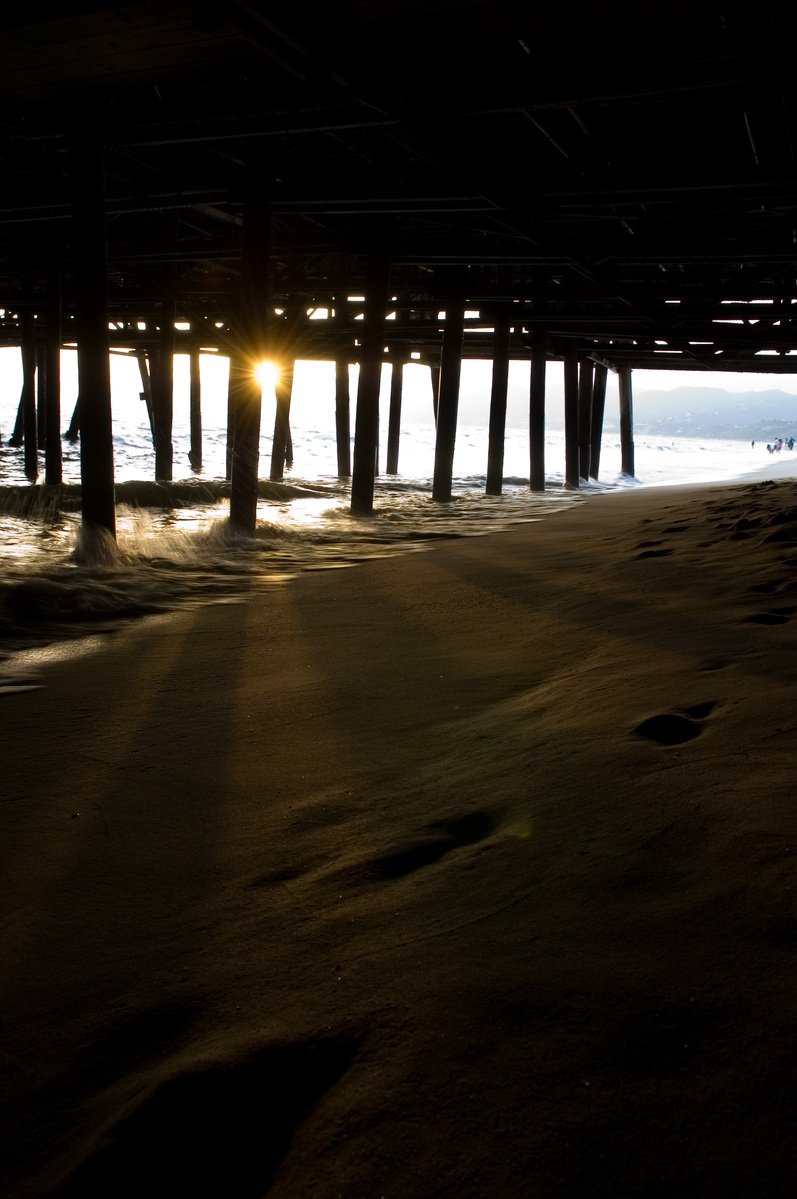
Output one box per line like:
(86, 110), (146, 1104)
(0, 0), (797, 372)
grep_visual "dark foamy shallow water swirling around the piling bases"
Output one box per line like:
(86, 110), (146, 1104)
(0, 478), (579, 661)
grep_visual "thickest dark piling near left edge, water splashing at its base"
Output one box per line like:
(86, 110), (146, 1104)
(70, 135), (116, 538)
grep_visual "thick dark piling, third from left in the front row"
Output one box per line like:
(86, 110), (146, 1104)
(351, 257), (390, 517)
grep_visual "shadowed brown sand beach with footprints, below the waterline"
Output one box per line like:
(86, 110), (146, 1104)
(0, 480), (797, 1199)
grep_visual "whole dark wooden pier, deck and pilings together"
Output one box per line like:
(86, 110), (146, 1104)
(0, 0), (797, 535)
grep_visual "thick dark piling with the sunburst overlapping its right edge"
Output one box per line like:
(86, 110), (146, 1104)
(230, 157), (271, 536)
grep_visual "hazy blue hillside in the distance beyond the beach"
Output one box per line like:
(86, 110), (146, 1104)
(605, 387), (797, 441)
